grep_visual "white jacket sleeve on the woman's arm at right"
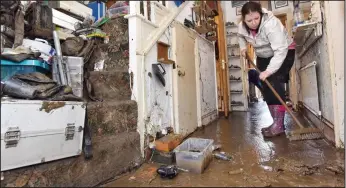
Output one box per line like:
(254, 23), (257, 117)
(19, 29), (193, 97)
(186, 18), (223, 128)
(266, 19), (289, 74)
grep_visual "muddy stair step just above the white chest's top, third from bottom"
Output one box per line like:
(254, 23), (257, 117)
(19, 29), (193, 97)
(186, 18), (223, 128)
(89, 70), (132, 101)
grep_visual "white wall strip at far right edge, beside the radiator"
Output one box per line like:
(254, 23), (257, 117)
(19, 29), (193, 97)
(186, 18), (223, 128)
(324, 1), (345, 147)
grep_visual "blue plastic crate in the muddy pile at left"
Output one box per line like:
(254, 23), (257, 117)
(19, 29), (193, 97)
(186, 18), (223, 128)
(1, 60), (50, 81)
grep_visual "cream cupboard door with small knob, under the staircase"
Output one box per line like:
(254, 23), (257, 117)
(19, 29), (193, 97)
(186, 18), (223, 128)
(172, 23), (197, 135)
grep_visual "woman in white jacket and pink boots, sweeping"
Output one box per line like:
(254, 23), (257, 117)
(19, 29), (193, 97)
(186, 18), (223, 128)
(238, 2), (295, 137)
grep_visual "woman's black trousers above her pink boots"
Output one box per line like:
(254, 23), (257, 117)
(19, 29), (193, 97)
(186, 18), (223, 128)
(257, 50), (295, 105)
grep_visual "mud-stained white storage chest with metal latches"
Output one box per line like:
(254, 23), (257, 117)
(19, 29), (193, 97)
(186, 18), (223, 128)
(1, 98), (86, 171)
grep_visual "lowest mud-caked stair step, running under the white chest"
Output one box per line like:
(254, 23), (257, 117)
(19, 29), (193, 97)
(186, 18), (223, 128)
(1, 132), (142, 187)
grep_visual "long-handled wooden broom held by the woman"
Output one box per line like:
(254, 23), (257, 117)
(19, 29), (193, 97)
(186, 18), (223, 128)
(246, 54), (324, 141)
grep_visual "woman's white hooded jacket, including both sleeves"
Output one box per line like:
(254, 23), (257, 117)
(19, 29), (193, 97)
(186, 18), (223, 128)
(238, 8), (293, 74)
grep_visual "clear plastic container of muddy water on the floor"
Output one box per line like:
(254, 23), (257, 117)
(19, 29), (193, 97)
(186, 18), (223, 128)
(174, 138), (214, 174)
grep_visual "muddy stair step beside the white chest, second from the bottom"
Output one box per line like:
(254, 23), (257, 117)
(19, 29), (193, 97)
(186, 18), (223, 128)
(87, 100), (137, 136)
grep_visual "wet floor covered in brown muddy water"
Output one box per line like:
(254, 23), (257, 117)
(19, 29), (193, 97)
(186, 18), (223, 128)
(105, 102), (345, 187)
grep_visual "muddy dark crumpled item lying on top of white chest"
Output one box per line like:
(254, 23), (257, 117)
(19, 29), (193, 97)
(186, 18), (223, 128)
(3, 72), (82, 101)
